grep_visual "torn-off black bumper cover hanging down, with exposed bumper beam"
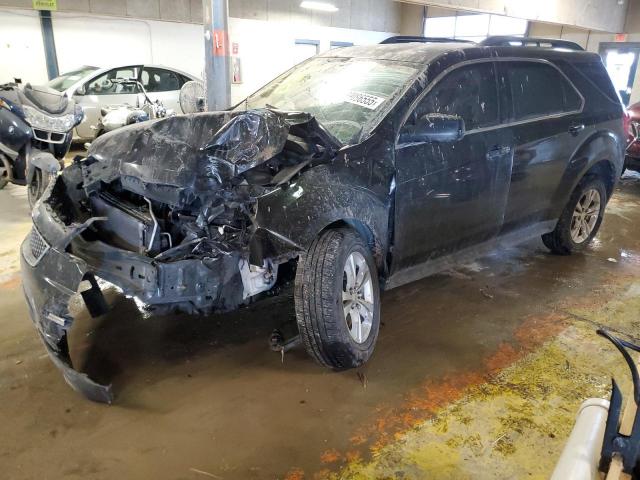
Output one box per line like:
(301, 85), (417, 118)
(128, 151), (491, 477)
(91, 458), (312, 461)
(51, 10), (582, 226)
(20, 207), (242, 403)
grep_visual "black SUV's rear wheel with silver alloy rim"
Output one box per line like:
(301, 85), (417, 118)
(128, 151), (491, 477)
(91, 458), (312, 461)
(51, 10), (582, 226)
(542, 177), (607, 255)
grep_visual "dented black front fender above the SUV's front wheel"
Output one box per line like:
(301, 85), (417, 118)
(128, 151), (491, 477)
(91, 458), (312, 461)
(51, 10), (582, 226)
(251, 165), (390, 265)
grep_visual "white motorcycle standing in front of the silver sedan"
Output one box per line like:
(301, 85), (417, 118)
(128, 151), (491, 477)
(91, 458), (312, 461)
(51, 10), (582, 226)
(91, 78), (175, 138)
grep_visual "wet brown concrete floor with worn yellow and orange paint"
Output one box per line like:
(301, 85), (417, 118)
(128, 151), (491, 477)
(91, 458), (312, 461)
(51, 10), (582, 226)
(0, 175), (640, 480)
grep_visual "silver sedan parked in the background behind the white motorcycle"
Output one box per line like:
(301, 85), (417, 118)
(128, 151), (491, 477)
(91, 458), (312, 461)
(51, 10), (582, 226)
(47, 65), (197, 141)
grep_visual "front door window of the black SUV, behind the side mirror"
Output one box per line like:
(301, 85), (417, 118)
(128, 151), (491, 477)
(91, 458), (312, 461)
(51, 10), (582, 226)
(415, 62), (498, 131)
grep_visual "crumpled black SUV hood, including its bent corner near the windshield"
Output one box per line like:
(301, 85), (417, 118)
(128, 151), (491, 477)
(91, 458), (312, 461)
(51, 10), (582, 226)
(83, 109), (339, 205)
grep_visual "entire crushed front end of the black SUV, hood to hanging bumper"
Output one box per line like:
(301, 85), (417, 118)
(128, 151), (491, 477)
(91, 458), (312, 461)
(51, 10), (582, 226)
(21, 110), (339, 403)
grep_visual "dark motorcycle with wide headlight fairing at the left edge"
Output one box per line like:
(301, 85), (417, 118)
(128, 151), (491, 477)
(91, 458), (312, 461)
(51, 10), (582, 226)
(0, 83), (84, 206)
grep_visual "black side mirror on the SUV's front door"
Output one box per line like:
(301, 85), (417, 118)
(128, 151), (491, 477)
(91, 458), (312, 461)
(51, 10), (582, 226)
(399, 113), (465, 143)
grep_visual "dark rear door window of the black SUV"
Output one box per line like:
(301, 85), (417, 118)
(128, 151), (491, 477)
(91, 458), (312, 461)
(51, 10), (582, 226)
(502, 62), (582, 121)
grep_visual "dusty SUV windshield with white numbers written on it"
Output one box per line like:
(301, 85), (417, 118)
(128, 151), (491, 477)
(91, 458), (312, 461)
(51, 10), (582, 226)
(237, 57), (417, 144)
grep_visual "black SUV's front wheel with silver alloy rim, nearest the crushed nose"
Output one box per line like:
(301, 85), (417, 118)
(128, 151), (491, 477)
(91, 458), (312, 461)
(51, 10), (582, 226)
(294, 228), (380, 370)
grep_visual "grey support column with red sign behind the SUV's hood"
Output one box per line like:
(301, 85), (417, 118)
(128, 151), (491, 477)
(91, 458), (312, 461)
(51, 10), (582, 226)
(202, 0), (231, 111)
